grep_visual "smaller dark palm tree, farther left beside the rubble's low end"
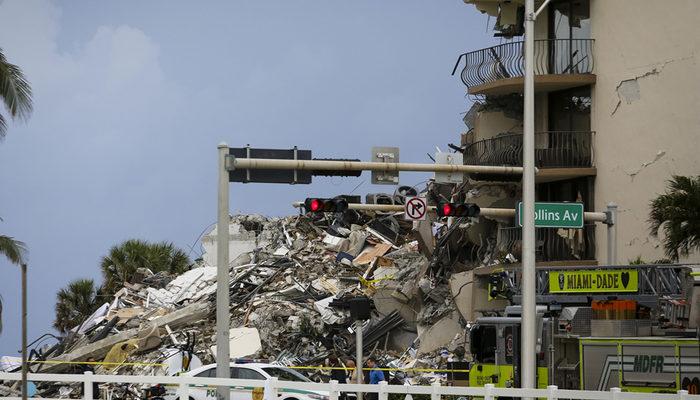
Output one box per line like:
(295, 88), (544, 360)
(53, 279), (98, 334)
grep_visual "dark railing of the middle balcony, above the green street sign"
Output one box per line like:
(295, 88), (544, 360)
(464, 131), (595, 168)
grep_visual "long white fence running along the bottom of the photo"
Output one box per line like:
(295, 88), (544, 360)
(0, 372), (700, 400)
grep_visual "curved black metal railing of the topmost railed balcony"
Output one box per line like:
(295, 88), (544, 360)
(452, 39), (593, 87)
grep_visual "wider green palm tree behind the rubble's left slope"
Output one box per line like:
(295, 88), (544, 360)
(100, 239), (191, 295)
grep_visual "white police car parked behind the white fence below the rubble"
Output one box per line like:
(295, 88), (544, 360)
(163, 363), (329, 400)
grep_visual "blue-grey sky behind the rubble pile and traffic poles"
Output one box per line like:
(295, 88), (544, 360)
(0, 0), (494, 355)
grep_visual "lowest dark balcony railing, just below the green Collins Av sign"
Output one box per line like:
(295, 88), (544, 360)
(496, 224), (595, 261)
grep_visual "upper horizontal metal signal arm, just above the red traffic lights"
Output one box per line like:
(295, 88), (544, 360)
(229, 156), (523, 175)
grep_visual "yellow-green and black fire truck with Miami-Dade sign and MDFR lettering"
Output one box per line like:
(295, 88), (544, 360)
(469, 264), (700, 394)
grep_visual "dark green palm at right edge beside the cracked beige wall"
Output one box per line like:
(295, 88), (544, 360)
(649, 175), (700, 261)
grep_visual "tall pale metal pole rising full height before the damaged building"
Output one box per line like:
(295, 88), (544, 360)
(520, 0), (537, 394)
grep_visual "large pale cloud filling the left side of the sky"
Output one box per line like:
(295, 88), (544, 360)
(0, 0), (186, 354)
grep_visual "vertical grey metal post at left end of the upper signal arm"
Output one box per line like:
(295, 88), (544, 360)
(216, 143), (231, 400)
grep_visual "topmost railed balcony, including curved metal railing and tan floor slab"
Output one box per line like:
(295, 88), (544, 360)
(452, 39), (596, 95)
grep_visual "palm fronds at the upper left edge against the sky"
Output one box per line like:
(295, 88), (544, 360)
(0, 48), (33, 139)
